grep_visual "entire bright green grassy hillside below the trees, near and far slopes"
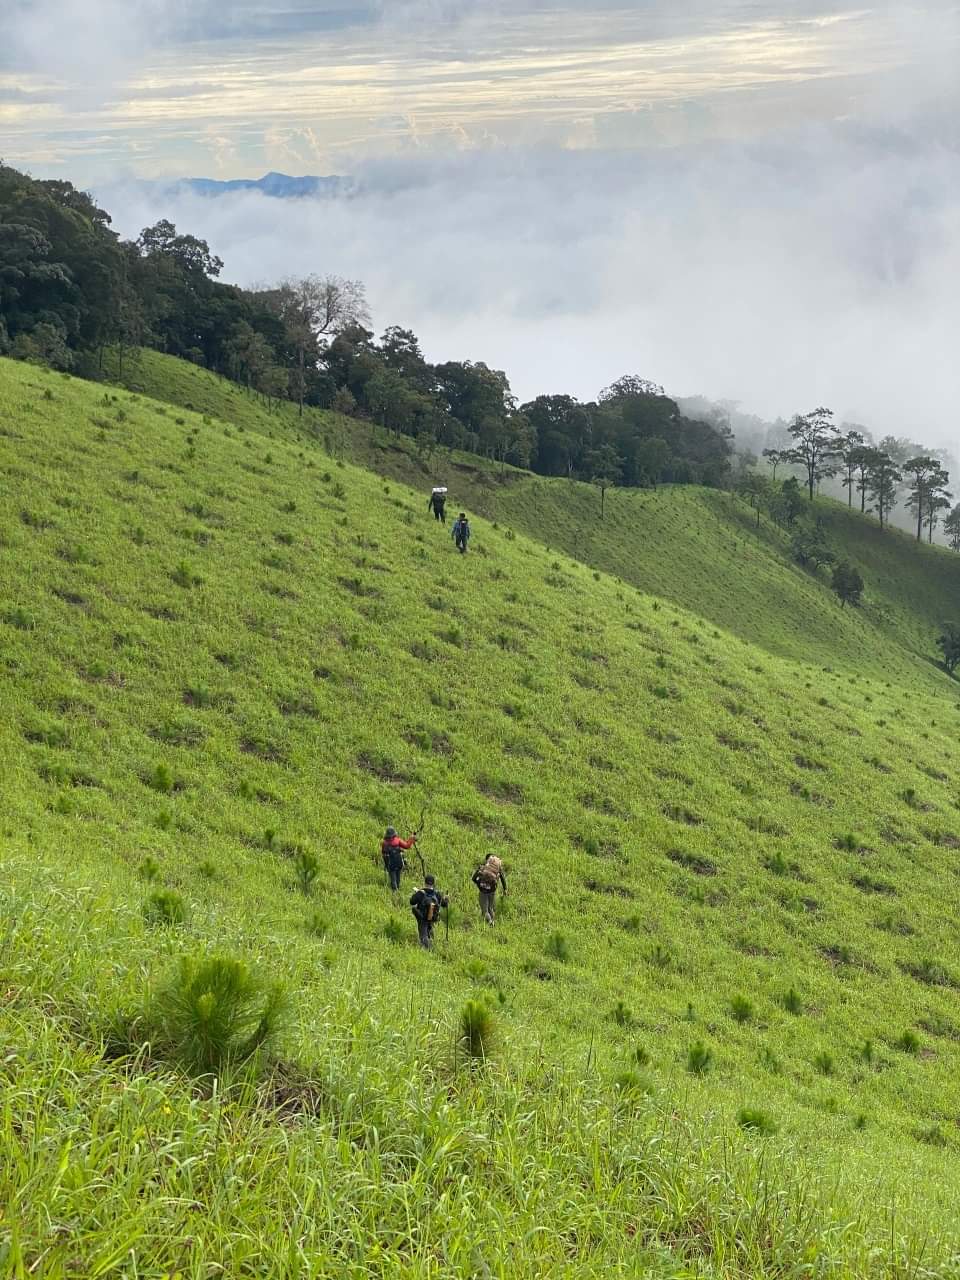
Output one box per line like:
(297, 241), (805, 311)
(0, 361), (960, 1277)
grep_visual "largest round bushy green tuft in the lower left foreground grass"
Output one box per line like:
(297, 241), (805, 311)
(151, 955), (289, 1075)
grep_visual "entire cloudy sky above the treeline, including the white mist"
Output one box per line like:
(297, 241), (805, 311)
(0, 0), (960, 445)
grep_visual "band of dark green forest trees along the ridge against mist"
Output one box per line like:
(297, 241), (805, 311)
(0, 164), (960, 540)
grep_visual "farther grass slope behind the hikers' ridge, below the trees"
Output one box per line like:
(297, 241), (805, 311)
(110, 340), (960, 678)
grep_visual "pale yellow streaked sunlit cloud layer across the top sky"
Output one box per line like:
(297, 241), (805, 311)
(0, 0), (956, 174)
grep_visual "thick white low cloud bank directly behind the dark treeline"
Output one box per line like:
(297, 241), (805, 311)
(99, 125), (960, 445)
